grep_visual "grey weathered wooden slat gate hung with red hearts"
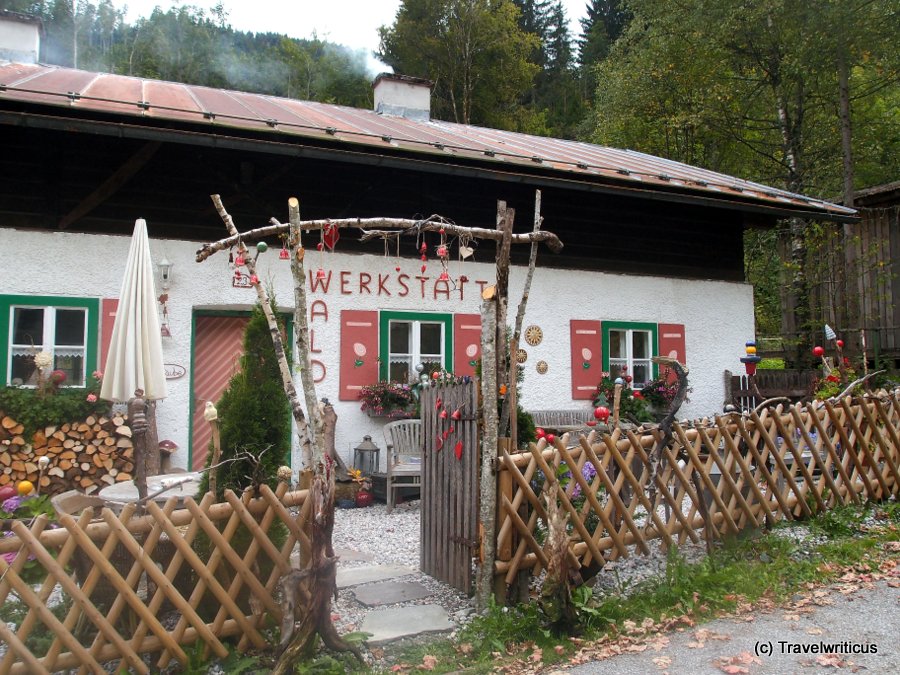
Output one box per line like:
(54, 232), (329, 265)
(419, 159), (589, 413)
(419, 381), (480, 593)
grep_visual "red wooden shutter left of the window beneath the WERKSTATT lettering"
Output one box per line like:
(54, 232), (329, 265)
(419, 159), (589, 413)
(338, 309), (378, 401)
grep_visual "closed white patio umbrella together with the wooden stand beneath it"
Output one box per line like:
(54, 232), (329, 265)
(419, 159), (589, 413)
(100, 218), (166, 499)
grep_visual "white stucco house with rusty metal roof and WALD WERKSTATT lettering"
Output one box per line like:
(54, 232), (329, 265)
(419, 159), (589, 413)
(0, 18), (854, 468)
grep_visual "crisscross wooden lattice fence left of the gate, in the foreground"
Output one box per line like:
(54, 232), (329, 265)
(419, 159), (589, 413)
(0, 483), (312, 675)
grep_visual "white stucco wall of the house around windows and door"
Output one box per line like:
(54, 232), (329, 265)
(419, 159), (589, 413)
(0, 223), (754, 466)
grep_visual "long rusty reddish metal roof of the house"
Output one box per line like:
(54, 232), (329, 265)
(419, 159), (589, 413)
(0, 63), (856, 220)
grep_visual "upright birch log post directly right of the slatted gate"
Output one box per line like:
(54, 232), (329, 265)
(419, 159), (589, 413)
(475, 287), (498, 611)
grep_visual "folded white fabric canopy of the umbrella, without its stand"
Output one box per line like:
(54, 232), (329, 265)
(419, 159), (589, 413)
(100, 218), (166, 403)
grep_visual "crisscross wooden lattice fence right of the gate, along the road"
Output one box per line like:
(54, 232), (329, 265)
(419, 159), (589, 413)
(494, 392), (900, 587)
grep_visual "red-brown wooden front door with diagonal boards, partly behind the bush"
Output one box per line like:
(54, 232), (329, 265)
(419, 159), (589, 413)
(191, 316), (250, 471)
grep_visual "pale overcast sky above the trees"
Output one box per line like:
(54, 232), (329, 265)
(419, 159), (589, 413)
(123, 0), (587, 70)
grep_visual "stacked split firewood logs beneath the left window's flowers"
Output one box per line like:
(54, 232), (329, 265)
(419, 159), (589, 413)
(0, 412), (134, 494)
